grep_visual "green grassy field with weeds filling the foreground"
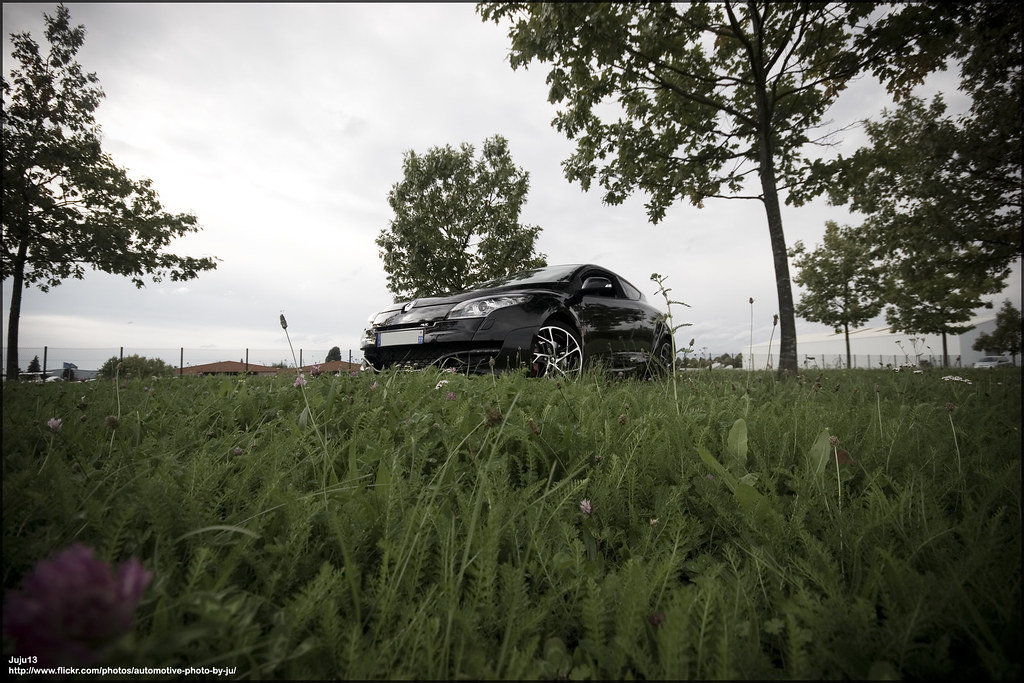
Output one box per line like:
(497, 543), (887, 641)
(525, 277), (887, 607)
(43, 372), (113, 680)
(3, 369), (1022, 679)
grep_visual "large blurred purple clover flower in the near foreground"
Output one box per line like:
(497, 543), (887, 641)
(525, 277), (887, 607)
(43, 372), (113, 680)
(3, 543), (152, 666)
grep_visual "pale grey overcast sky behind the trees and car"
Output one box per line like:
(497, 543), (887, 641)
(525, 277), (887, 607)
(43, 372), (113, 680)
(3, 3), (1021, 369)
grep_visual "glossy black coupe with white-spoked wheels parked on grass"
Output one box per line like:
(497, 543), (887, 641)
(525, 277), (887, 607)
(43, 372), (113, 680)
(361, 264), (673, 377)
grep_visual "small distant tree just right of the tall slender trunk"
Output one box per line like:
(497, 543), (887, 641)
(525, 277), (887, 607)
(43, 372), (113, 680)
(790, 221), (883, 368)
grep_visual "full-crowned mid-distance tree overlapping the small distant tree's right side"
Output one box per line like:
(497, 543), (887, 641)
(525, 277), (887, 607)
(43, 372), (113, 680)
(819, 97), (1020, 366)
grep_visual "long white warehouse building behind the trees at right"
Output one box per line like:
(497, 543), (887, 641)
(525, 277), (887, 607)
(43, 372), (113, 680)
(743, 315), (995, 370)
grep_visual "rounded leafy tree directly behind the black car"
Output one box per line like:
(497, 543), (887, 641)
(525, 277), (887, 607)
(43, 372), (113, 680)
(377, 135), (545, 300)
